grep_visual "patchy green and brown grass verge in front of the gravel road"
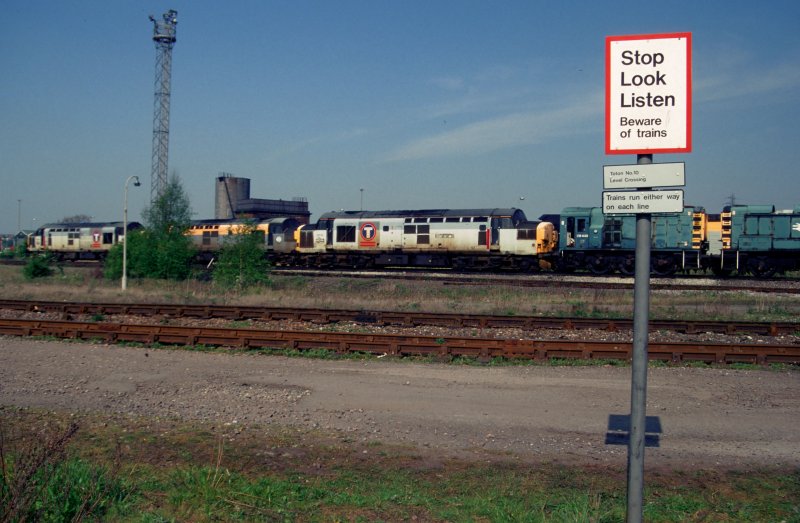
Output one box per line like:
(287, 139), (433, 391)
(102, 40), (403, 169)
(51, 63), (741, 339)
(0, 408), (800, 522)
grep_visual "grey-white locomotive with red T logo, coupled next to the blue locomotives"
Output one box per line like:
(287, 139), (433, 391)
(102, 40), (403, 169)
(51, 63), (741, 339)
(288, 208), (558, 270)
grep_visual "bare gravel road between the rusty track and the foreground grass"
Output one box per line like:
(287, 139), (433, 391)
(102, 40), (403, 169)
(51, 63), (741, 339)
(0, 337), (800, 470)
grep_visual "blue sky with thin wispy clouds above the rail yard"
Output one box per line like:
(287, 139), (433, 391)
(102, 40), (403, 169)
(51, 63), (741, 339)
(0, 0), (800, 232)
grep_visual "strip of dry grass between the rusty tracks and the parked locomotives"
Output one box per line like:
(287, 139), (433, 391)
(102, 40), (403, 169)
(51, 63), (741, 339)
(0, 266), (800, 321)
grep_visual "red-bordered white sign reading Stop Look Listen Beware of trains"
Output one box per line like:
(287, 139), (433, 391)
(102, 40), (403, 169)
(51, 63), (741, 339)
(606, 33), (692, 154)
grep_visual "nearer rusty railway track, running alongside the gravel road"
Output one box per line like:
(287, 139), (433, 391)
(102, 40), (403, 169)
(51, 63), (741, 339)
(0, 320), (800, 364)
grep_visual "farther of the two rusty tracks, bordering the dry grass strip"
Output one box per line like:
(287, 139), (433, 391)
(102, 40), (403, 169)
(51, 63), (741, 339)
(0, 300), (800, 336)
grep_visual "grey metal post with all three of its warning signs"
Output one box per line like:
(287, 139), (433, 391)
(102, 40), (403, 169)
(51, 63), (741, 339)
(603, 33), (692, 523)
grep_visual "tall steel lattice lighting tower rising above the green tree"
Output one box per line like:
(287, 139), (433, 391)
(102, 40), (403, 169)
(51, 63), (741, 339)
(150, 9), (178, 203)
